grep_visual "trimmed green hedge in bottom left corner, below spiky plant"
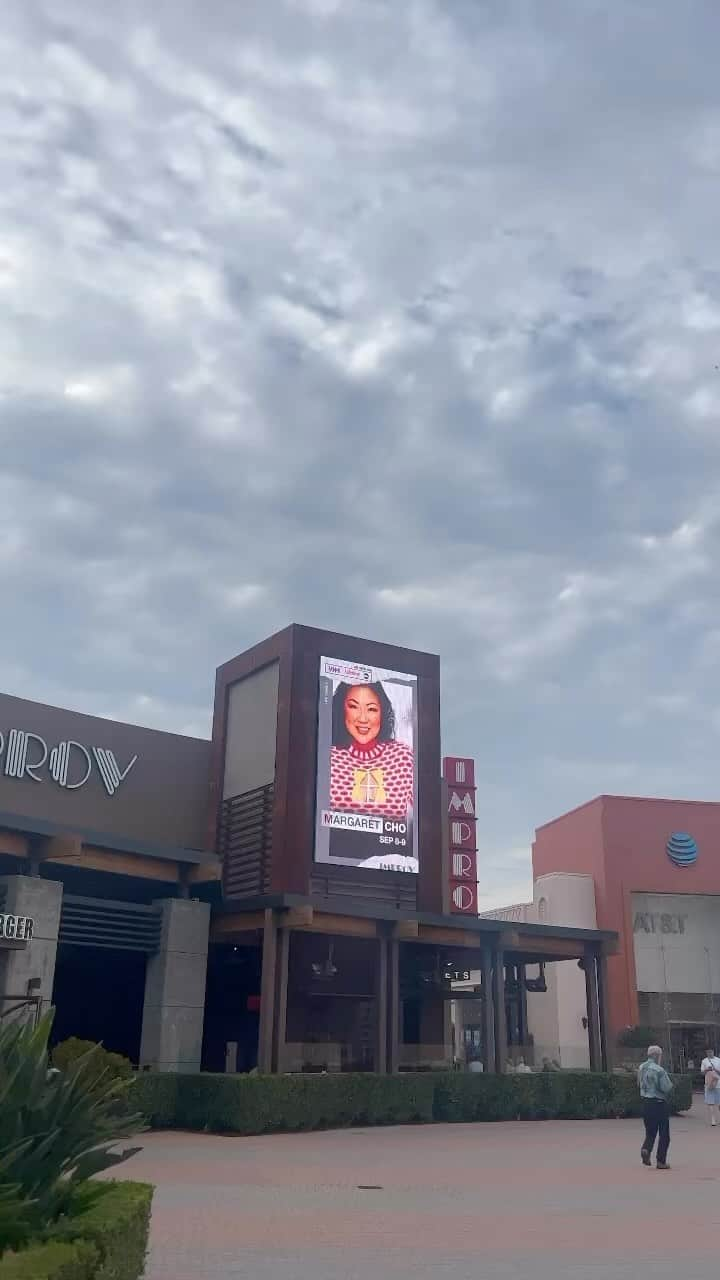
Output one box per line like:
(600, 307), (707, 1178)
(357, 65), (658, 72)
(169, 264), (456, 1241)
(0, 1181), (152, 1280)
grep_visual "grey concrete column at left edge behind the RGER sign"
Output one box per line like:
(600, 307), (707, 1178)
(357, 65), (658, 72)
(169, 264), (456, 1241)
(0, 876), (63, 1018)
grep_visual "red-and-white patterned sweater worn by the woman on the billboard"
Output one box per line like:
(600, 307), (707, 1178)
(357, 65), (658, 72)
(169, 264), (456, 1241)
(331, 740), (414, 820)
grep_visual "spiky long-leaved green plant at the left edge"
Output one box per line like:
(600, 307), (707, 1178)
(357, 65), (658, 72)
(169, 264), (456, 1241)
(0, 1012), (141, 1248)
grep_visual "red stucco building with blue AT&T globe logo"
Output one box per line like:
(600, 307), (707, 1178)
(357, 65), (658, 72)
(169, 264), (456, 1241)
(533, 796), (720, 1066)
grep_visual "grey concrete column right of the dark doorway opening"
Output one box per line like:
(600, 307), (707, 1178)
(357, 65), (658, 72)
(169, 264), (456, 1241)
(140, 899), (210, 1071)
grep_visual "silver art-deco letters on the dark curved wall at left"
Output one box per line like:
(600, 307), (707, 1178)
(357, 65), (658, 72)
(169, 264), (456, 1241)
(0, 728), (137, 796)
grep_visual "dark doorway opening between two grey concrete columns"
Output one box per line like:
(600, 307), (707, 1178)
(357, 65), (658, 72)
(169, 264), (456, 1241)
(53, 942), (146, 1064)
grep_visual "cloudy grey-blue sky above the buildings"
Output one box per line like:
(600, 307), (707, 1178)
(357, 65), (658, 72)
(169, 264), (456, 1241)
(0, 0), (720, 906)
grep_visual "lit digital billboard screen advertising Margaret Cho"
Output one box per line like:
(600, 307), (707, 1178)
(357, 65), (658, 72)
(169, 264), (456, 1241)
(315, 658), (418, 872)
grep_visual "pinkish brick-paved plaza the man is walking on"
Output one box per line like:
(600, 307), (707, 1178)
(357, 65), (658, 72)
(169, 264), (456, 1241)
(114, 1102), (720, 1280)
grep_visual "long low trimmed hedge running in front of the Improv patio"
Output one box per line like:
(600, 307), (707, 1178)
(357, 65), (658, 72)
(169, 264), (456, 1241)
(130, 1071), (692, 1136)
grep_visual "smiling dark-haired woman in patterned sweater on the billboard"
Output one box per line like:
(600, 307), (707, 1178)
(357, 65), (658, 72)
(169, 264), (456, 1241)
(331, 681), (414, 822)
